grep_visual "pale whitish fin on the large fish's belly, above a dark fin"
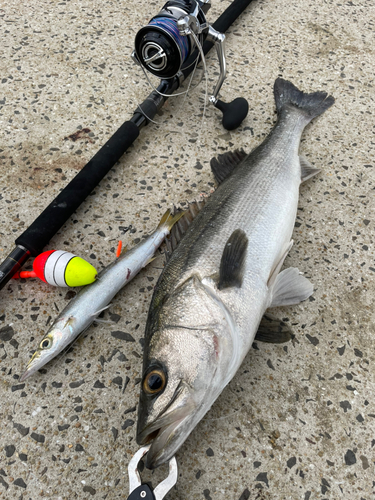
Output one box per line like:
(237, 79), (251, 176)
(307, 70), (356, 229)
(269, 267), (314, 307)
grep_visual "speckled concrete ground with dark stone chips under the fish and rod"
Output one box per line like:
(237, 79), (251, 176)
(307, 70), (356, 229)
(0, 0), (375, 500)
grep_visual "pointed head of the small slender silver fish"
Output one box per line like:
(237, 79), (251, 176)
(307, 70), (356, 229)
(20, 319), (74, 382)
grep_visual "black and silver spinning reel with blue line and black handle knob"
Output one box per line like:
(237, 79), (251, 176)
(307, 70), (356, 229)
(132, 0), (248, 130)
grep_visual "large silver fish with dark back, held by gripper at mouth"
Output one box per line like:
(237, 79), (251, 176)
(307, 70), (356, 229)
(136, 78), (334, 469)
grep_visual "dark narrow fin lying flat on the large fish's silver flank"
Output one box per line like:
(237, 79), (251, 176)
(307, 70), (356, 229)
(217, 229), (249, 290)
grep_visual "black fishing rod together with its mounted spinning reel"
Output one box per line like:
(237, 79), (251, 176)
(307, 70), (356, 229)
(0, 0), (252, 289)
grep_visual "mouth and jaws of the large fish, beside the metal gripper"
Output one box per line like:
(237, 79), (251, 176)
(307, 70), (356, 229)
(137, 382), (195, 469)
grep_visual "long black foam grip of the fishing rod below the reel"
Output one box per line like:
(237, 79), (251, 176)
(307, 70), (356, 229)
(16, 121), (139, 256)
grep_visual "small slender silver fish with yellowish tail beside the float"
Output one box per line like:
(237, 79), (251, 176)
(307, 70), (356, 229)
(21, 210), (184, 382)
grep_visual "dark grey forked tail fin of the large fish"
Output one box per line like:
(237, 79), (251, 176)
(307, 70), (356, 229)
(274, 78), (335, 121)
